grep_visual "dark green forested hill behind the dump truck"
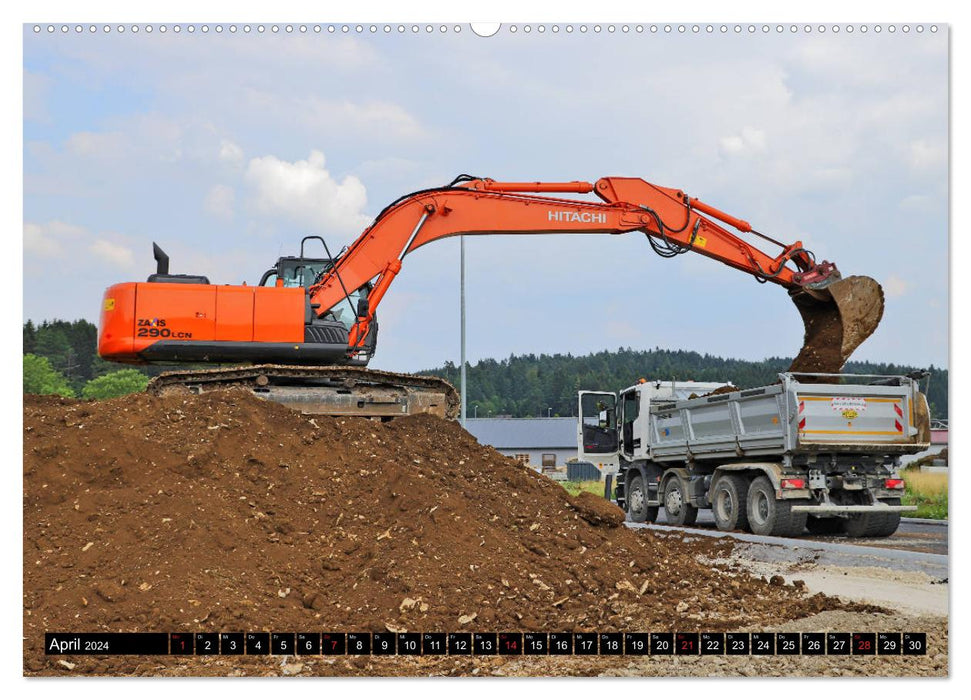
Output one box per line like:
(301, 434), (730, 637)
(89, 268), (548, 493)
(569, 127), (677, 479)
(420, 348), (948, 418)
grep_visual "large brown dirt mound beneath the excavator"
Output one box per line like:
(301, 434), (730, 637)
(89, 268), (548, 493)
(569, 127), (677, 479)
(24, 392), (864, 674)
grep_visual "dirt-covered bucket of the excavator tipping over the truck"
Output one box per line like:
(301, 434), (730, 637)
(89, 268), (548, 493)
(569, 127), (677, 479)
(789, 275), (883, 374)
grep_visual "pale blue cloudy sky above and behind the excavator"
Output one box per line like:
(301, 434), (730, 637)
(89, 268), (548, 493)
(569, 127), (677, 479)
(23, 23), (949, 371)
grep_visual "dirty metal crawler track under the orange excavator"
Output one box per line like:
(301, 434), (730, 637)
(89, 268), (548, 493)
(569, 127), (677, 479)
(147, 365), (460, 420)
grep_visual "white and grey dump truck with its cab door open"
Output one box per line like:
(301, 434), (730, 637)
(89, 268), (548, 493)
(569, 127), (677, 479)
(577, 372), (930, 537)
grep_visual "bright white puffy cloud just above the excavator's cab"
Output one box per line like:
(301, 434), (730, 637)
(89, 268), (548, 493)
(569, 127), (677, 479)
(246, 150), (370, 233)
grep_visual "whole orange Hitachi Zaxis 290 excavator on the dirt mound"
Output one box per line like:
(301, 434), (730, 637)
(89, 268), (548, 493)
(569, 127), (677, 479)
(98, 175), (883, 417)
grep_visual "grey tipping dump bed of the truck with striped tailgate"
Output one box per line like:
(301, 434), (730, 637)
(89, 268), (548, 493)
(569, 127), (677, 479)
(649, 373), (930, 462)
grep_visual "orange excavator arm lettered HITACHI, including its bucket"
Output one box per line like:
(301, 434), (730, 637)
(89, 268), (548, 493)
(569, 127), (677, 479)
(310, 176), (883, 372)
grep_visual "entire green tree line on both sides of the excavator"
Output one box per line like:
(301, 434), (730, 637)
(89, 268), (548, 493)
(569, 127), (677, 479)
(23, 319), (948, 418)
